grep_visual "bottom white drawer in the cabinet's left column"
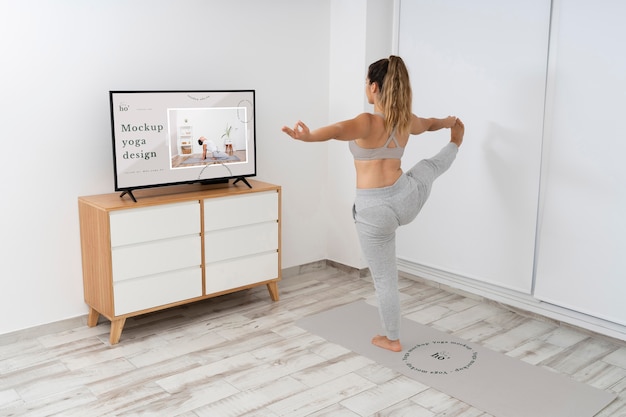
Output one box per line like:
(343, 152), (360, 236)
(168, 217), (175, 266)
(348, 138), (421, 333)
(113, 268), (202, 316)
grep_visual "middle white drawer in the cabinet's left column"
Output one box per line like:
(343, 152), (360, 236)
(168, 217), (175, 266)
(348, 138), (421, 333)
(111, 235), (202, 281)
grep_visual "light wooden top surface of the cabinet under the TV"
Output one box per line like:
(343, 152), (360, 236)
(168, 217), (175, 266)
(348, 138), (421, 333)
(78, 178), (281, 210)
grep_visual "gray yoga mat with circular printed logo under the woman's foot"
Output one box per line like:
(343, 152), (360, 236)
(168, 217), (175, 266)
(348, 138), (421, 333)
(296, 301), (616, 417)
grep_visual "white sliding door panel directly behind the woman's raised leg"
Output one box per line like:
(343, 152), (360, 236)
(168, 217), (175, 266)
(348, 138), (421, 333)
(398, 0), (550, 294)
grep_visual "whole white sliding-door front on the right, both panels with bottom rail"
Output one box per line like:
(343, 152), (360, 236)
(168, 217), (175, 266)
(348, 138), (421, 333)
(398, 0), (626, 338)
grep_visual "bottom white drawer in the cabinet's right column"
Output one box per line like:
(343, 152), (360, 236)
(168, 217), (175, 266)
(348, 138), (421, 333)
(204, 252), (278, 294)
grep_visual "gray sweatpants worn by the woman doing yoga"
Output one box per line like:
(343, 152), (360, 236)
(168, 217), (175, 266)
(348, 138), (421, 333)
(353, 143), (459, 340)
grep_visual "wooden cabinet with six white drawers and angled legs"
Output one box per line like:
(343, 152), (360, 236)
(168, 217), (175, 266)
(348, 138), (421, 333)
(78, 180), (281, 344)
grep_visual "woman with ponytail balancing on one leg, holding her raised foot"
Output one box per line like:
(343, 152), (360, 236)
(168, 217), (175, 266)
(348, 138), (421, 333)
(282, 55), (465, 352)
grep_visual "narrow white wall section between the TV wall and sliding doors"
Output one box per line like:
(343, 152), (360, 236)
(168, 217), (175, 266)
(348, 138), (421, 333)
(324, 0), (394, 268)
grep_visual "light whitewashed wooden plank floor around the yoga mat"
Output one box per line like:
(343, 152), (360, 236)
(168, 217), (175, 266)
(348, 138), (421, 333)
(0, 262), (626, 417)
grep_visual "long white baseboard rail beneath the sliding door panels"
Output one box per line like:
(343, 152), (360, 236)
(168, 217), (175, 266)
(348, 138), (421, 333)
(398, 259), (626, 341)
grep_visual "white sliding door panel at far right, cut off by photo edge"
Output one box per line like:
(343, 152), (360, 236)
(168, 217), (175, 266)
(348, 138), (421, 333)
(535, 0), (626, 325)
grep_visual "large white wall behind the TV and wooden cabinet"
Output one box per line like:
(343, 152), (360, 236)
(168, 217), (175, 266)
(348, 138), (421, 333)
(0, 0), (332, 334)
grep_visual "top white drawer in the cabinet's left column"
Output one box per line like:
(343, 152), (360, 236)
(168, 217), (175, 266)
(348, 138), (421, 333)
(109, 201), (200, 247)
